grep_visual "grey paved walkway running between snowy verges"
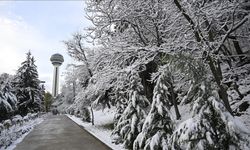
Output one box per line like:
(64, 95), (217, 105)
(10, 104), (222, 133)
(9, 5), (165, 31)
(15, 115), (110, 150)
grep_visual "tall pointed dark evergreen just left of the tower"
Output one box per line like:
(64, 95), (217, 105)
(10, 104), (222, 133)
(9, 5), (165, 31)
(14, 52), (42, 115)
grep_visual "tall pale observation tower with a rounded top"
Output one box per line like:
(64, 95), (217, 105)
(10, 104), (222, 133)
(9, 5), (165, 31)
(50, 53), (64, 97)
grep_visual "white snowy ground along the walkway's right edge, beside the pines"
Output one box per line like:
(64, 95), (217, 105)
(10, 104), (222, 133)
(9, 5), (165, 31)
(67, 109), (123, 150)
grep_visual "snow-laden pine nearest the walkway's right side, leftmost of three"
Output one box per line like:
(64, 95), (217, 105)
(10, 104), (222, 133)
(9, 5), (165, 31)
(112, 72), (149, 149)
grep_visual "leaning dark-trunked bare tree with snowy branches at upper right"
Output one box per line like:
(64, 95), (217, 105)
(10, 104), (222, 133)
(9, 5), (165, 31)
(174, 0), (249, 115)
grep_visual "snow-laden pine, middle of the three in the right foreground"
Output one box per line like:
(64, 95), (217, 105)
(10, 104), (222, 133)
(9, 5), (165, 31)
(133, 67), (173, 150)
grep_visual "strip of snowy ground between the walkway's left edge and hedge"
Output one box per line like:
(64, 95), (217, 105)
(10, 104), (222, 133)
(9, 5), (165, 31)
(0, 116), (45, 150)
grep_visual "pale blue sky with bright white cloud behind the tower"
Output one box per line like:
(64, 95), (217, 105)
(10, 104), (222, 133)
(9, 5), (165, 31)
(0, 0), (90, 91)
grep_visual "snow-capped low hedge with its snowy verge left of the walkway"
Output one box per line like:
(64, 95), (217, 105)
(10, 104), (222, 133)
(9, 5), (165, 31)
(0, 113), (43, 150)
